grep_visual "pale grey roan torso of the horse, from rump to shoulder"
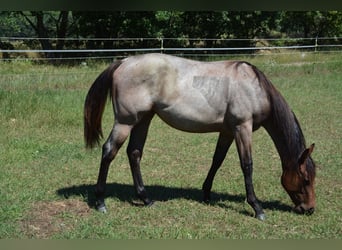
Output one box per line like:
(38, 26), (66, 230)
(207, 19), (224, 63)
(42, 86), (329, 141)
(114, 54), (268, 132)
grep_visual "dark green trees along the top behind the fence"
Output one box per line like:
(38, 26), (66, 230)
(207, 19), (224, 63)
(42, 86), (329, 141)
(0, 11), (342, 58)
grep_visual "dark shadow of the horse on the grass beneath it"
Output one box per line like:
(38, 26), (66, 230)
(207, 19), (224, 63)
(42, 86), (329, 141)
(57, 183), (291, 215)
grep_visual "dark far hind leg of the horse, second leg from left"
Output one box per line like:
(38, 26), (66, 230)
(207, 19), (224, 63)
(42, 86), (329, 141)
(127, 113), (153, 205)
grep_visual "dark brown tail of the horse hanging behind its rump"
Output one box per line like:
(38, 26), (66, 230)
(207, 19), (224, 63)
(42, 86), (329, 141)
(84, 61), (121, 148)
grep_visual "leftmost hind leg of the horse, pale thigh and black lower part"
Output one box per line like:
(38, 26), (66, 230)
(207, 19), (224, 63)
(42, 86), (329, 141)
(95, 123), (131, 212)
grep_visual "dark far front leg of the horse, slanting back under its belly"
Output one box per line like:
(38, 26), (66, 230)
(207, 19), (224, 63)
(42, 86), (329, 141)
(202, 132), (234, 202)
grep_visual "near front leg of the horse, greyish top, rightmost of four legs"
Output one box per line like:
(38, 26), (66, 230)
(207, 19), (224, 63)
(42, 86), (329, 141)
(235, 122), (265, 220)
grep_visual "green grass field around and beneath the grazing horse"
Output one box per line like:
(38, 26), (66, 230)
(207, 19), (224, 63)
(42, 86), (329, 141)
(0, 53), (342, 239)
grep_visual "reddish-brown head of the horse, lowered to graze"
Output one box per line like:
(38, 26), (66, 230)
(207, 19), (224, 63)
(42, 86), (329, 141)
(281, 144), (316, 215)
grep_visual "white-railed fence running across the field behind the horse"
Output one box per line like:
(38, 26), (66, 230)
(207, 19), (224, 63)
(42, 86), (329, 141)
(0, 37), (342, 60)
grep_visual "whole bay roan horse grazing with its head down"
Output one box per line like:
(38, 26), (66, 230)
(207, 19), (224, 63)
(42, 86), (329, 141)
(84, 54), (315, 220)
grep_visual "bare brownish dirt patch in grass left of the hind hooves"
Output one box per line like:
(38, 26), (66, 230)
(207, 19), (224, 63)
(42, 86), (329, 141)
(21, 199), (91, 239)
